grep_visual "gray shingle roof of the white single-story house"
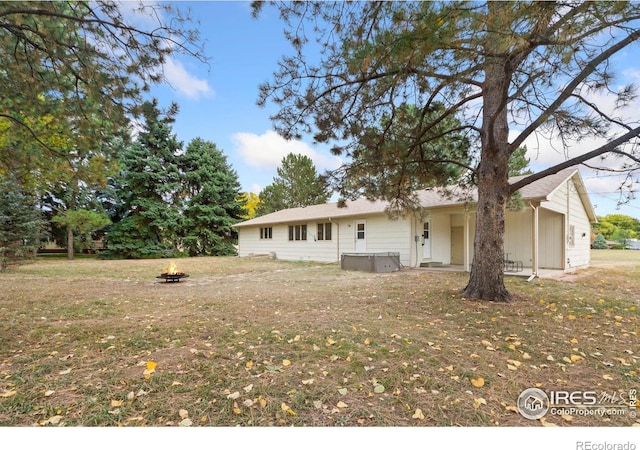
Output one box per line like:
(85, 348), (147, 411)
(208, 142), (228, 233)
(234, 168), (595, 228)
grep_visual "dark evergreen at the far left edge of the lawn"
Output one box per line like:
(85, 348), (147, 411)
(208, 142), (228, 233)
(0, 178), (44, 271)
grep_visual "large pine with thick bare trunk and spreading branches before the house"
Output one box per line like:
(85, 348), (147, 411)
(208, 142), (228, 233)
(253, 1), (640, 301)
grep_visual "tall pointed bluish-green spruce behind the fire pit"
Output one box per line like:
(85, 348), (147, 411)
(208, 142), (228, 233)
(104, 100), (182, 258)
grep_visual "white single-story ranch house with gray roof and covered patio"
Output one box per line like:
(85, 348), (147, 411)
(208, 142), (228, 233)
(235, 169), (596, 275)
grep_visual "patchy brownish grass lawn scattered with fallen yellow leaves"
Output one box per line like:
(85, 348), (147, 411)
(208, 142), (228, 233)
(0, 251), (640, 427)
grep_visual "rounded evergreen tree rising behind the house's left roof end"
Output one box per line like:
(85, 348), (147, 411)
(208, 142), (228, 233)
(256, 153), (330, 216)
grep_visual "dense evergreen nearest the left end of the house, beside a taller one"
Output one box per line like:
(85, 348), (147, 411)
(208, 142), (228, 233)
(180, 138), (246, 256)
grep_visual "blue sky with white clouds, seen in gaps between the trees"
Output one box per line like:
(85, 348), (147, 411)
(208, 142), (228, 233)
(145, 0), (640, 218)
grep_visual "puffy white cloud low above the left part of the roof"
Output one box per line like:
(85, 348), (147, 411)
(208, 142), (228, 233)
(231, 130), (341, 172)
